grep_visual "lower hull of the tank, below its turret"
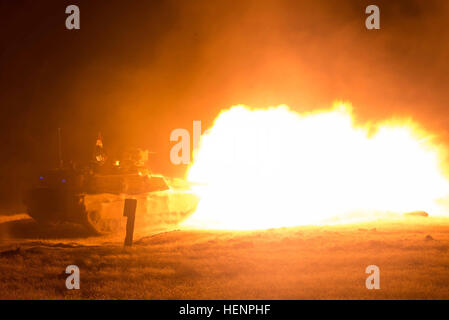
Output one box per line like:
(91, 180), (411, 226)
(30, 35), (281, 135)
(25, 188), (199, 234)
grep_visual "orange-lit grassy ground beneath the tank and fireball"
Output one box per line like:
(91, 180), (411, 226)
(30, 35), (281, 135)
(0, 215), (449, 299)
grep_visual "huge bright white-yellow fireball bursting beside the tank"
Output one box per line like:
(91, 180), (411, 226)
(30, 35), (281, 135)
(184, 103), (449, 230)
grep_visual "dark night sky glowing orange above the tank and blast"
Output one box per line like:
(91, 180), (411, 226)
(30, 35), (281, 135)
(0, 0), (449, 209)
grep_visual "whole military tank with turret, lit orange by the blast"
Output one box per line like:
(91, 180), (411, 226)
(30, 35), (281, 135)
(24, 132), (198, 234)
